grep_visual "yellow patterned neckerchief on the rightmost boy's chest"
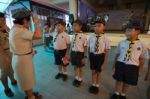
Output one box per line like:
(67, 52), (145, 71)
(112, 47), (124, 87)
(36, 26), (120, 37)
(124, 39), (139, 61)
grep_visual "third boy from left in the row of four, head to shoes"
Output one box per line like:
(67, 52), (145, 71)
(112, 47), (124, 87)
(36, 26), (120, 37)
(88, 19), (110, 94)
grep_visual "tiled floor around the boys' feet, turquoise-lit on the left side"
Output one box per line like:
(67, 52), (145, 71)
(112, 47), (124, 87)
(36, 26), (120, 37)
(0, 46), (149, 99)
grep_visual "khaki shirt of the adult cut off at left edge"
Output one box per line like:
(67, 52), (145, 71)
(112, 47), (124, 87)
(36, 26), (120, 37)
(0, 26), (9, 49)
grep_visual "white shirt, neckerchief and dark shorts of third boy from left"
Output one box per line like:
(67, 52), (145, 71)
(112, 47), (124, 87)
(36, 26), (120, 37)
(88, 34), (110, 72)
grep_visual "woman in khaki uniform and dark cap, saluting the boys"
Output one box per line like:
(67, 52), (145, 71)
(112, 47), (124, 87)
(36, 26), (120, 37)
(9, 10), (42, 99)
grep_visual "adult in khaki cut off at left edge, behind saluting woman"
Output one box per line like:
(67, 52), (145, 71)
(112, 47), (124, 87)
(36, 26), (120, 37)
(0, 13), (17, 97)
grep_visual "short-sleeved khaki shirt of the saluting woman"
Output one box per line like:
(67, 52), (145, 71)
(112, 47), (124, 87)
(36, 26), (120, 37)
(9, 25), (34, 54)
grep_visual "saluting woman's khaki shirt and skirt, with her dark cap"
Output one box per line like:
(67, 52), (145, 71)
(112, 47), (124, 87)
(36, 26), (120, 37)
(9, 12), (35, 90)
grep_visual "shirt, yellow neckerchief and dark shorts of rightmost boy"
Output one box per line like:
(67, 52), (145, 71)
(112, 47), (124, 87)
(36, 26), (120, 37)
(113, 39), (149, 85)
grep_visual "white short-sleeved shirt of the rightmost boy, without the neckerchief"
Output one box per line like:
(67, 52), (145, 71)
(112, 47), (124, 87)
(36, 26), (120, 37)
(117, 40), (149, 66)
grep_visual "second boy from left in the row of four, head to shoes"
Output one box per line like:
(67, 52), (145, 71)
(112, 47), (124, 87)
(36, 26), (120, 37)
(71, 20), (87, 87)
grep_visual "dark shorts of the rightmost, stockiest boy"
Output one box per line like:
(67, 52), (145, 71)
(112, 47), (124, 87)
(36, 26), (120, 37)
(113, 61), (139, 86)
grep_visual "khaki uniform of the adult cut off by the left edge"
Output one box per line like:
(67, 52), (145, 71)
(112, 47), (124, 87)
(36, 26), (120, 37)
(0, 27), (14, 82)
